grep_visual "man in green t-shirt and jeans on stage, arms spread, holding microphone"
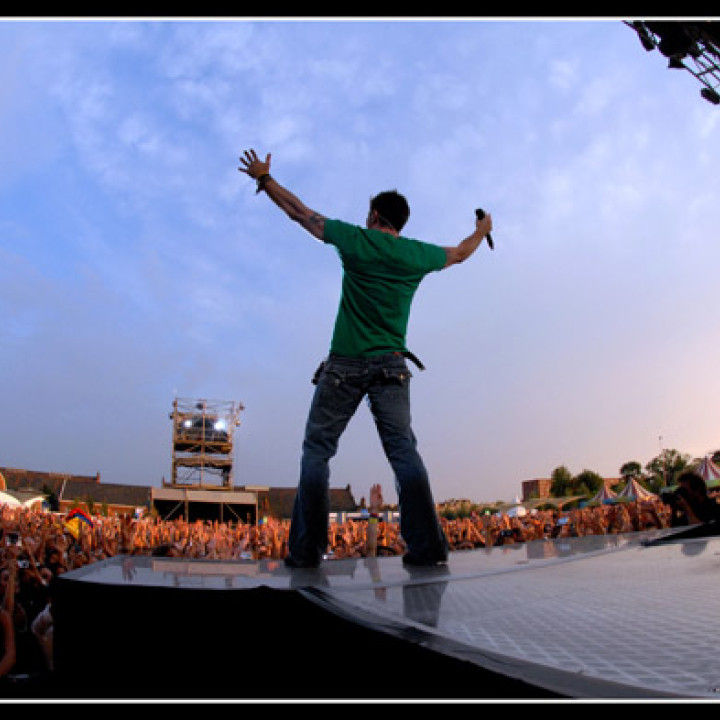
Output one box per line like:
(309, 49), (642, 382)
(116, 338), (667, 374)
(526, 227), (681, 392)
(238, 150), (492, 567)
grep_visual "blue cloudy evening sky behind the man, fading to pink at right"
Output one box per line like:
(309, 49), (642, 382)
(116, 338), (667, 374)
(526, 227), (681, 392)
(0, 18), (720, 502)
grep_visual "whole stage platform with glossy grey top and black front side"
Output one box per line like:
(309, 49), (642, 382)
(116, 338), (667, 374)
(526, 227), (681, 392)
(54, 532), (720, 700)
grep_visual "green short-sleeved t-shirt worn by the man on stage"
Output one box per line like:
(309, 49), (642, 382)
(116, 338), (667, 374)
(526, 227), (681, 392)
(323, 220), (446, 357)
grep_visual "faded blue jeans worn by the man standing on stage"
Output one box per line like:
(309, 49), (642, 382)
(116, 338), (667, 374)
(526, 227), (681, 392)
(289, 353), (448, 564)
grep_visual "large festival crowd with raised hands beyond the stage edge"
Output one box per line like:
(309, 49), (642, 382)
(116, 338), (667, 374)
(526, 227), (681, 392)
(0, 492), (700, 683)
